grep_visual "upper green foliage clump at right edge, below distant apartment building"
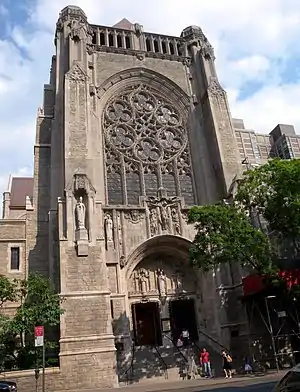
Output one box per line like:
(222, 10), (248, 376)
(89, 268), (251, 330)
(236, 159), (300, 239)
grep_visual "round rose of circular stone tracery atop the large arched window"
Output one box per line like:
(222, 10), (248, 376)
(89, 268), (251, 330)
(103, 85), (187, 164)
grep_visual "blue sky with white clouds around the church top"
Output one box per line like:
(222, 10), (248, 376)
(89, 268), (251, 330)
(0, 0), (300, 193)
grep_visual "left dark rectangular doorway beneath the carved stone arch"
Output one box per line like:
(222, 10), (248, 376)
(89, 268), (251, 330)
(132, 302), (162, 346)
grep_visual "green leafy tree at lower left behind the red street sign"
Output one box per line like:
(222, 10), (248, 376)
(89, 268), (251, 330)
(0, 274), (63, 369)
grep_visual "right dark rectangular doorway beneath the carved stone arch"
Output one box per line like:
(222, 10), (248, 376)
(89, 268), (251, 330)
(169, 299), (198, 342)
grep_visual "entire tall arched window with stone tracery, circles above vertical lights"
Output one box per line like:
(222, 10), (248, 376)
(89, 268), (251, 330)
(103, 84), (194, 205)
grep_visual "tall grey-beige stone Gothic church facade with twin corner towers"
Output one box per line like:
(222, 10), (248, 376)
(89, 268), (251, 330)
(0, 6), (251, 389)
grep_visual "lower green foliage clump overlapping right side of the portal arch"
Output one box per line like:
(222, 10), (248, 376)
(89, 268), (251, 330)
(188, 204), (273, 273)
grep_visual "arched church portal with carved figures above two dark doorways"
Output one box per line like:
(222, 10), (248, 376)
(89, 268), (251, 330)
(127, 236), (200, 346)
